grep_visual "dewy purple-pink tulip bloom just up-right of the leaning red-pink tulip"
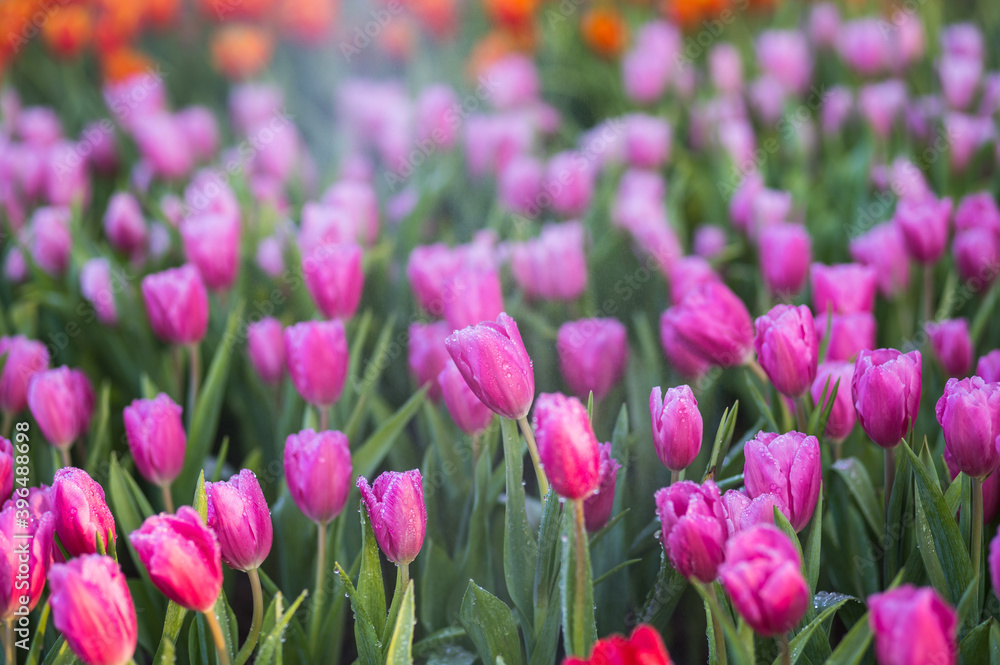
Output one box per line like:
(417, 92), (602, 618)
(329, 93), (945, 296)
(205, 469), (272, 571)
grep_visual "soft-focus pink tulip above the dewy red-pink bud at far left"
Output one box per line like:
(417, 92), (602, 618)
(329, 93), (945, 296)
(28, 367), (94, 449)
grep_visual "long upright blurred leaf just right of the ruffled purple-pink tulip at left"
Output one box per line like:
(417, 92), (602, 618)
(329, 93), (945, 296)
(174, 302), (243, 496)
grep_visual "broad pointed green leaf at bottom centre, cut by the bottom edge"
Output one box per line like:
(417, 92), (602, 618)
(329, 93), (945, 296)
(458, 580), (524, 665)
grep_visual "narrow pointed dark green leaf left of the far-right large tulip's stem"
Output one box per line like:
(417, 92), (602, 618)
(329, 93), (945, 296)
(900, 442), (974, 604)
